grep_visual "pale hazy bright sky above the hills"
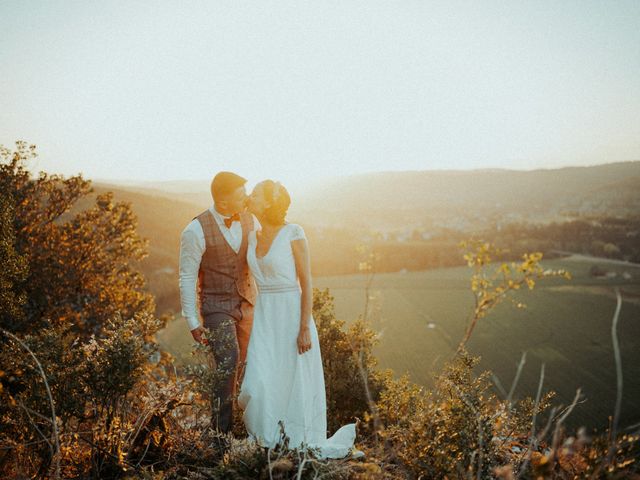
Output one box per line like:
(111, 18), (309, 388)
(0, 0), (640, 189)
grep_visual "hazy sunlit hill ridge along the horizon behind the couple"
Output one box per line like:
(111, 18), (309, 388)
(109, 161), (640, 230)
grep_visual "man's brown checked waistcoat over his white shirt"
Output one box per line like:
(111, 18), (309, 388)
(195, 210), (256, 318)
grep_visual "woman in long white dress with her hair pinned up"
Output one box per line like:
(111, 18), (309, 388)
(238, 180), (362, 458)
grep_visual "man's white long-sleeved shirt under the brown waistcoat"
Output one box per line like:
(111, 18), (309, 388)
(179, 206), (260, 330)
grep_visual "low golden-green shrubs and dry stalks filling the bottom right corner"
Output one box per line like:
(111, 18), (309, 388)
(378, 351), (640, 479)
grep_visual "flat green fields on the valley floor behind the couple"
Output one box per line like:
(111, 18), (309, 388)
(159, 257), (640, 429)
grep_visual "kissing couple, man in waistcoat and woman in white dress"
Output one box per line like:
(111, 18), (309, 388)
(180, 172), (362, 458)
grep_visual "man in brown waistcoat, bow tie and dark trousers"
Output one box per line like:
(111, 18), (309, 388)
(180, 172), (260, 432)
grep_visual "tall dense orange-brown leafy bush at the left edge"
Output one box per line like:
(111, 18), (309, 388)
(0, 142), (162, 477)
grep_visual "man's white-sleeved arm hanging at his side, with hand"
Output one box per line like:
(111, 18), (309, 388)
(179, 220), (205, 342)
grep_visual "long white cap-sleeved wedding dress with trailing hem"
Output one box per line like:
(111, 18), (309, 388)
(238, 223), (356, 458)
